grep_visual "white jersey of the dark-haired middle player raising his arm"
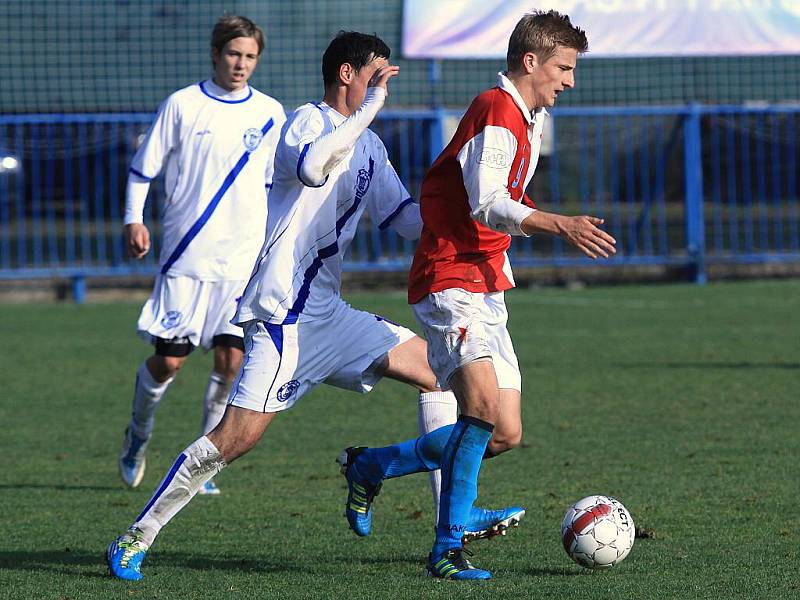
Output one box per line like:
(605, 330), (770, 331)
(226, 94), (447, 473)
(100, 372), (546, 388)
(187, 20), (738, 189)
(233, 98), (422, 324)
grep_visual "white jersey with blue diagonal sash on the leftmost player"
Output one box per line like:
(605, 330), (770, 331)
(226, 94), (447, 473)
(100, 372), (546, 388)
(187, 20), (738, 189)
(130, 80), (286, 281)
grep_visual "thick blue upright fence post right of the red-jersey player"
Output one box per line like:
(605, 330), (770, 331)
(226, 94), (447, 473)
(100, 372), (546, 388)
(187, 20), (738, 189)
(683, 104), (706, 284)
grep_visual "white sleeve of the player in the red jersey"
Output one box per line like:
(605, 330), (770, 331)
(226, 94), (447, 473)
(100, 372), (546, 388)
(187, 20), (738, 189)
(457, 116), (533, 235)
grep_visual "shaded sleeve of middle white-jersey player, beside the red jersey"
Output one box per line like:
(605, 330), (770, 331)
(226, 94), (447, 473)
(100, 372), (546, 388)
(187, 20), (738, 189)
(367, 142), (422, 240)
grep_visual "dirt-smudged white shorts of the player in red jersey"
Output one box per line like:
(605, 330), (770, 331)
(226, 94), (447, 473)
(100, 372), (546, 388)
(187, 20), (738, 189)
(411, 288), (522, 391)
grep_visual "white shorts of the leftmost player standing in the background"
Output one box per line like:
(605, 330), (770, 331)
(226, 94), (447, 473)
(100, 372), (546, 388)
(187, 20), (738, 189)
(137, 275), (247, 350)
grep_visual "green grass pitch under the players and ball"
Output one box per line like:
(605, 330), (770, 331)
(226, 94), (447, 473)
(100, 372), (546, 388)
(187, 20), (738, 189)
(0, 281), (800, 600)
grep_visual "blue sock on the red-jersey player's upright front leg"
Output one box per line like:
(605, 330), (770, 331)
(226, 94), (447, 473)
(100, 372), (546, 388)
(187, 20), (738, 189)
(432, 415), (494, 557)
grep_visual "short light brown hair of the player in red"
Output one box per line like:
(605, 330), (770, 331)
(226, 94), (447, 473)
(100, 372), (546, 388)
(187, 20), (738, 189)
(506, 10), (589, 71)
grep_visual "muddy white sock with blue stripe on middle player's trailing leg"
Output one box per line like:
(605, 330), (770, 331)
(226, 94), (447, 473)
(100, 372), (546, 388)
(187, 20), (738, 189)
(131, 436), (226, 546)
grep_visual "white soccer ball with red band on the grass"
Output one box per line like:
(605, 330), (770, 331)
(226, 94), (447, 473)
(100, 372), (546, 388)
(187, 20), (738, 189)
(561, 496), (636, 569)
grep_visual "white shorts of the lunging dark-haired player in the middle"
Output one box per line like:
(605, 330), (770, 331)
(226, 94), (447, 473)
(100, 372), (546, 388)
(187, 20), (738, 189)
(228, 300), (415, 413)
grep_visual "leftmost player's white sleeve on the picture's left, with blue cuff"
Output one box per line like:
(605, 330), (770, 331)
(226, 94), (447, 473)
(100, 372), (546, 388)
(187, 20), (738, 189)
(123, 96), (180, 225)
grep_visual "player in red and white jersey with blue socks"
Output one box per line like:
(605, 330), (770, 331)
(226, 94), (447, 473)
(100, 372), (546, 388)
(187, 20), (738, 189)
(346, 11), (616, 579)
